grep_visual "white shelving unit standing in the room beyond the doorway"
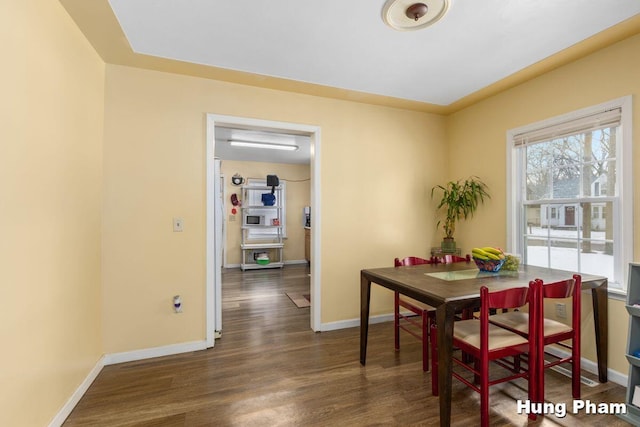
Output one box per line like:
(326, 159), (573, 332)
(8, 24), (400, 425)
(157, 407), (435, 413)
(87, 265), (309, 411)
(240, 185), (284, 271)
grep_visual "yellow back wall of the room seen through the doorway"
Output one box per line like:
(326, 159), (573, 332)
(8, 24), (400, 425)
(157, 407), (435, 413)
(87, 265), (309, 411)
(221, 160), (311, 266)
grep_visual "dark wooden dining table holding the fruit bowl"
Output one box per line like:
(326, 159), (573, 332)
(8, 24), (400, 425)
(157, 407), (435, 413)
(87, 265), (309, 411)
(360, 262), (608, 426)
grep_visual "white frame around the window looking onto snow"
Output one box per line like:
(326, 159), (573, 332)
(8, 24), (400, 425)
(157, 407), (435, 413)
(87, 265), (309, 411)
(506, 95), (634, 296)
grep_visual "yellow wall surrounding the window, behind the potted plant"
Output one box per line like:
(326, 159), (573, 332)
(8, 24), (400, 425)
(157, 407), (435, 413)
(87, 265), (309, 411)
(447, 32), (640, 374)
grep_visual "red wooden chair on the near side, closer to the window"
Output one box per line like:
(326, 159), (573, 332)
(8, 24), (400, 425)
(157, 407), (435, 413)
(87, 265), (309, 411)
(490, 274), (582, 402)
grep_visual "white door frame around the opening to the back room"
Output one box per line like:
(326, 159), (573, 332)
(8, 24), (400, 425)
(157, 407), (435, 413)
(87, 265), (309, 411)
(205, 114), (322, 347)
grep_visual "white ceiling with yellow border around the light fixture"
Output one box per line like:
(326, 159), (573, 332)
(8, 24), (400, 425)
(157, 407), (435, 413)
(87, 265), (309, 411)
(59, 0), (640, 164)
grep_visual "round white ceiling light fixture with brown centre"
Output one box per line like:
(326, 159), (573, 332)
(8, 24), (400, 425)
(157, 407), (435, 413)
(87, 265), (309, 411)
(382, 0), (450, 31)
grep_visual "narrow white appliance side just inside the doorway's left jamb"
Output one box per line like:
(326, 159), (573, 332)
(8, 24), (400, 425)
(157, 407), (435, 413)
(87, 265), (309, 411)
(213, 159), (226, 338)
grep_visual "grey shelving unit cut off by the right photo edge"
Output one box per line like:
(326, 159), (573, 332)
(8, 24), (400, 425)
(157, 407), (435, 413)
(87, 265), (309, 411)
(618, 264), (640, 426)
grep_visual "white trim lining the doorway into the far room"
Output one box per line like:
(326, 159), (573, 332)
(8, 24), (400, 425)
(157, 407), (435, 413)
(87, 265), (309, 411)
(206, 114), (321, 347)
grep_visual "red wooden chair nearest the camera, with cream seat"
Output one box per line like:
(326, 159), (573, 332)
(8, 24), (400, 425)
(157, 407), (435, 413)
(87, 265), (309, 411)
(431, 282), (537, 427)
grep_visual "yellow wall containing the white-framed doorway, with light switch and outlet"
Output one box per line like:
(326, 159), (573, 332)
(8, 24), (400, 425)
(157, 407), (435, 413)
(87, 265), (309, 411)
(102, 65), (446, 353)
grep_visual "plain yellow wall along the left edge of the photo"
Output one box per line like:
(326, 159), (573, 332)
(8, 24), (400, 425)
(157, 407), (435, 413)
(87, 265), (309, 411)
(0, 0), (105, 426)
